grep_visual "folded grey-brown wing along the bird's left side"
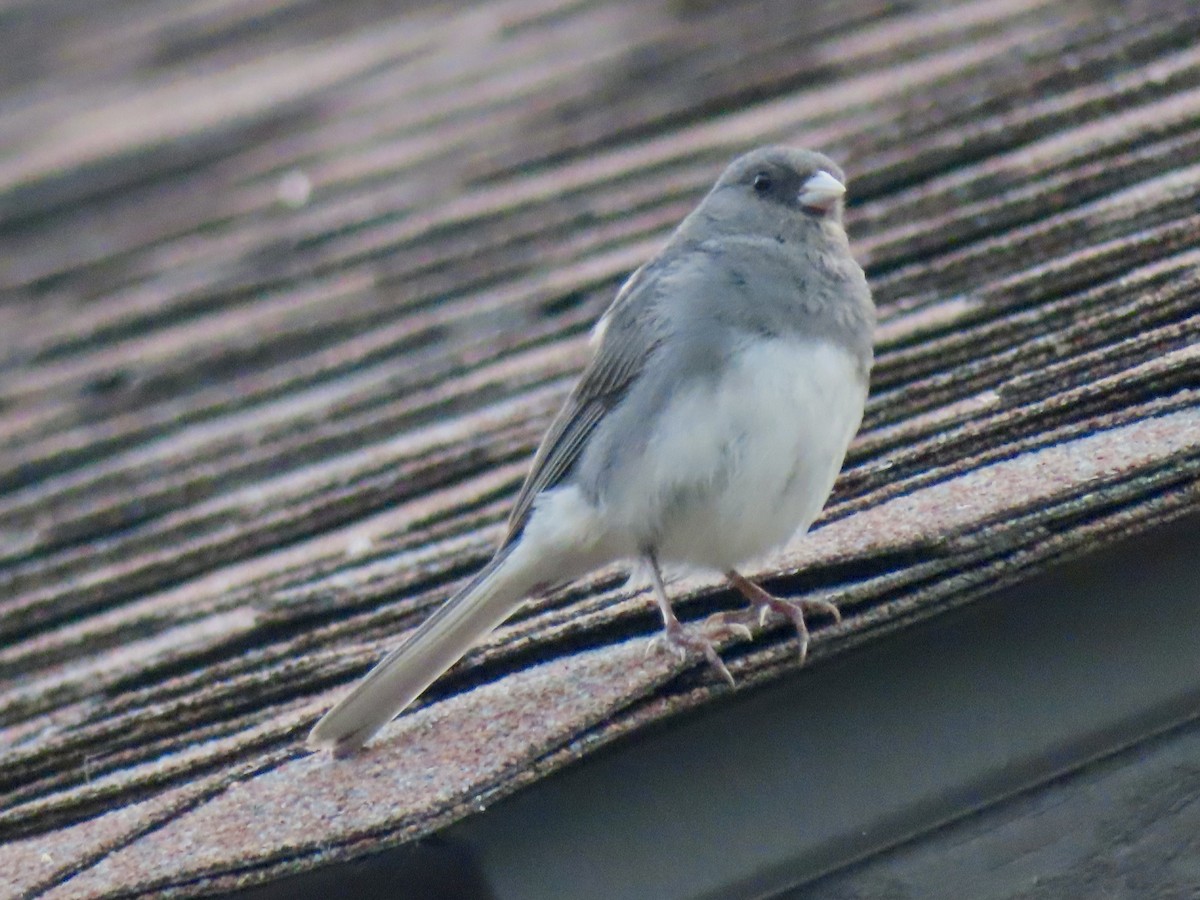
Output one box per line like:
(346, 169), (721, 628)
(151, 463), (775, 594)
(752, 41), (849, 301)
(500, 263), (658, 547)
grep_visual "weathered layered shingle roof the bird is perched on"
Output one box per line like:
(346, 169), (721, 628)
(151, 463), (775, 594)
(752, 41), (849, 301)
(0, 0), (1200, 898)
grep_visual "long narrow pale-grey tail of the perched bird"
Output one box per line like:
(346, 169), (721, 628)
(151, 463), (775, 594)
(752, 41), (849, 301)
(308, 547), (540, 756)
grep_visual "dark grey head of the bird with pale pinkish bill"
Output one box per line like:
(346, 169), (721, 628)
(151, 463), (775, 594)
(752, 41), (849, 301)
(688, 146), (846, 247)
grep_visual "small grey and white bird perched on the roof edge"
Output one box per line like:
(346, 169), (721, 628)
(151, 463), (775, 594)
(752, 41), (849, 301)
(307, 145), (875, 756)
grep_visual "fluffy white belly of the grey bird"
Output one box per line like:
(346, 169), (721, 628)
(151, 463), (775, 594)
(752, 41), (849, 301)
(602, 340), (866, 571)
